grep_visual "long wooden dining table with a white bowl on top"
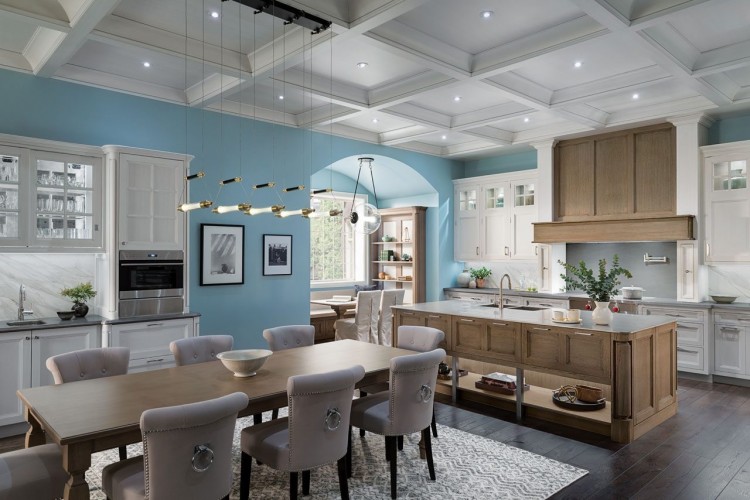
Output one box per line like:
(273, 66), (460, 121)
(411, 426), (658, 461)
(18, 340), (413, 500)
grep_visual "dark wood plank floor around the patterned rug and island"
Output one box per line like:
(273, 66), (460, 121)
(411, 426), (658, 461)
(5, 378), (750, 500)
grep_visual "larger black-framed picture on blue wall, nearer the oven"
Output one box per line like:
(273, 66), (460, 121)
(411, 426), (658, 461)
(200, 224), (245, 286)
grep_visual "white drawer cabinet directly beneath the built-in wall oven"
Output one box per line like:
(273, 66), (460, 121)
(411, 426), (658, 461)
(105, 318), (196, 373)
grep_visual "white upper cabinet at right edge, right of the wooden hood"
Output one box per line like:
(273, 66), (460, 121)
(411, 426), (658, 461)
(701, 141), (750, 264)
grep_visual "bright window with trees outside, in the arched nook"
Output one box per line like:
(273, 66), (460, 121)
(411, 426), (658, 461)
(310, 193), (367, 284)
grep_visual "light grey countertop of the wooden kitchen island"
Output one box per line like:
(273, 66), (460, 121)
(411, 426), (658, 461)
(392, 300), (674, 335)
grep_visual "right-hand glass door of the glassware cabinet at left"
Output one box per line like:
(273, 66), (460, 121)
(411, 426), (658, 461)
(33, 155), (95, 242)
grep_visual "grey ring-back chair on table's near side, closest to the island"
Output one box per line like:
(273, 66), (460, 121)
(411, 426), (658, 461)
(347, 349), (445, 498)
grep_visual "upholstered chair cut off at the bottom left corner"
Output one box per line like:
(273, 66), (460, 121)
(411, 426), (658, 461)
(0, 444), (68, 500)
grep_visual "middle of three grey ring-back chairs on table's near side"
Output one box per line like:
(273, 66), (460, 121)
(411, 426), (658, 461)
(240, 365), (365, 500)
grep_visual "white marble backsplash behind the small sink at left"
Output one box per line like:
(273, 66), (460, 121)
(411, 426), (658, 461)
(0, 253), (99, 320)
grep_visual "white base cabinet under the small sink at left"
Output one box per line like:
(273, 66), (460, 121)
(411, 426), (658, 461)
(0, 325), (100, 427)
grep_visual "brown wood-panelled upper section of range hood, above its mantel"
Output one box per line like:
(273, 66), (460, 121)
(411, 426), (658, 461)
(555, 124), (676, 221)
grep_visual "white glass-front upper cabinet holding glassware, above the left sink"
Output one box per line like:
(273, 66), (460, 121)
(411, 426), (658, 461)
(0, 140), (103, 251)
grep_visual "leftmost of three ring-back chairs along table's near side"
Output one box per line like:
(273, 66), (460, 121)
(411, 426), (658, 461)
(102, 392), (248, 500)
